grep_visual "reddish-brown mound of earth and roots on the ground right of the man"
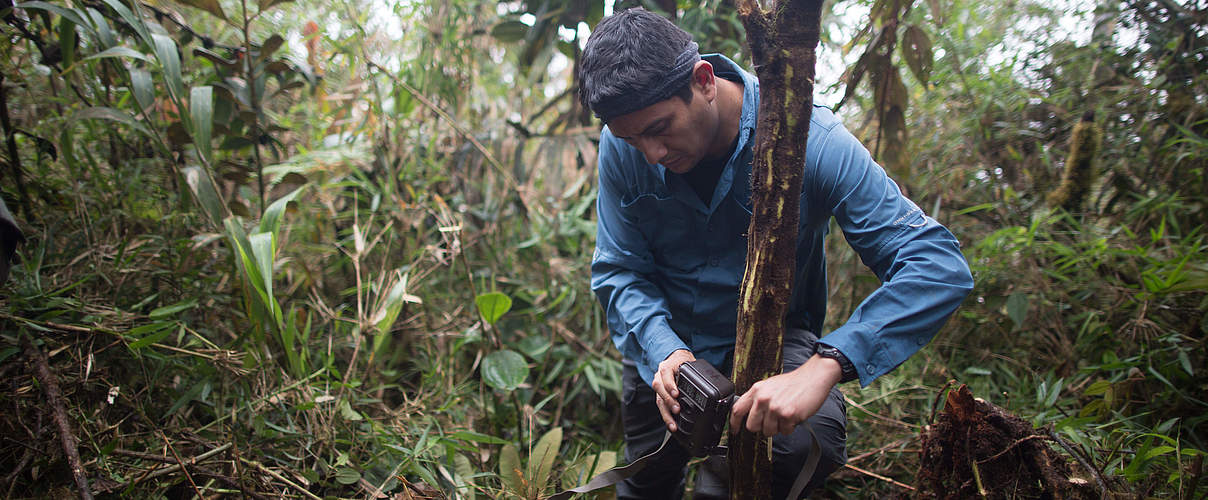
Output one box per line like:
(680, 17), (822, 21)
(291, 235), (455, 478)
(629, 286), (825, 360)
(914, 385), (1099, 499)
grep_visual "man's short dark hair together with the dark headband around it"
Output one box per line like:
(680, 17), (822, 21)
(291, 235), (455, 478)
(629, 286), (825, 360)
(579, 7), (692, 120)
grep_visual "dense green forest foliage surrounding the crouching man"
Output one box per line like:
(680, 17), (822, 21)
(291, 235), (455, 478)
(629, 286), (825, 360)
(0, 0), (1208, 499)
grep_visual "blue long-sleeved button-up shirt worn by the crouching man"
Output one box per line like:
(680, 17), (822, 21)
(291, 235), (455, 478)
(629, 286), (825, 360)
(592, 54), (972, 385)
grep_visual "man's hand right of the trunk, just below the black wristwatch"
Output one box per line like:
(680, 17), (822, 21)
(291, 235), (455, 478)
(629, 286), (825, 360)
(730, 354), (843, 436)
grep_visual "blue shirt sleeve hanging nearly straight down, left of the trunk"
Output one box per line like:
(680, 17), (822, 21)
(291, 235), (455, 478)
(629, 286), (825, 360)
(592, 129), (687, 384)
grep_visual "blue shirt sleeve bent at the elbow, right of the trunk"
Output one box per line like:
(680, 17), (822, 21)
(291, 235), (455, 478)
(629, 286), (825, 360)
(806, 120), (974, 386)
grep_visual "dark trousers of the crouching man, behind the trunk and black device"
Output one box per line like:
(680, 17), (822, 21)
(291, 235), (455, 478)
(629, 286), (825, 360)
(616, 330), (847, 500)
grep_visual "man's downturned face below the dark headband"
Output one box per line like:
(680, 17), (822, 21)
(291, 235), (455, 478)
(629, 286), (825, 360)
(609, 70), (718, 174)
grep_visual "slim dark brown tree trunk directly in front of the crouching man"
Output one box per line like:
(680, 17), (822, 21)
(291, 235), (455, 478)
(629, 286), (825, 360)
(730, 0), (823, 499)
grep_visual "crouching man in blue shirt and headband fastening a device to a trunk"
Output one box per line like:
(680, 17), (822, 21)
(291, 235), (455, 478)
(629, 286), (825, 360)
(579, 8), (972, 499)
